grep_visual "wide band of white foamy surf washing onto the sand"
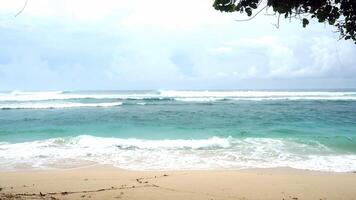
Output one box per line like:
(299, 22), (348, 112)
(0, 135), (356, 172)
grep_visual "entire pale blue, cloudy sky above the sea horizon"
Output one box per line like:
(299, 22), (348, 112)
(0, 0), (356, 91)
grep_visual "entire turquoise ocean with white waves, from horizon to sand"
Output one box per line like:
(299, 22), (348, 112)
(0, 90), (356, 172)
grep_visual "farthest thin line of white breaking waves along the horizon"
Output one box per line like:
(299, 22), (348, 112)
(0, 90), (356, 102)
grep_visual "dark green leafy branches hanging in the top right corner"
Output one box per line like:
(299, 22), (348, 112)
(213, 0), (356, 43)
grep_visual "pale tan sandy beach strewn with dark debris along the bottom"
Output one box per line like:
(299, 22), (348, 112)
(0, 166), (356, 200)
